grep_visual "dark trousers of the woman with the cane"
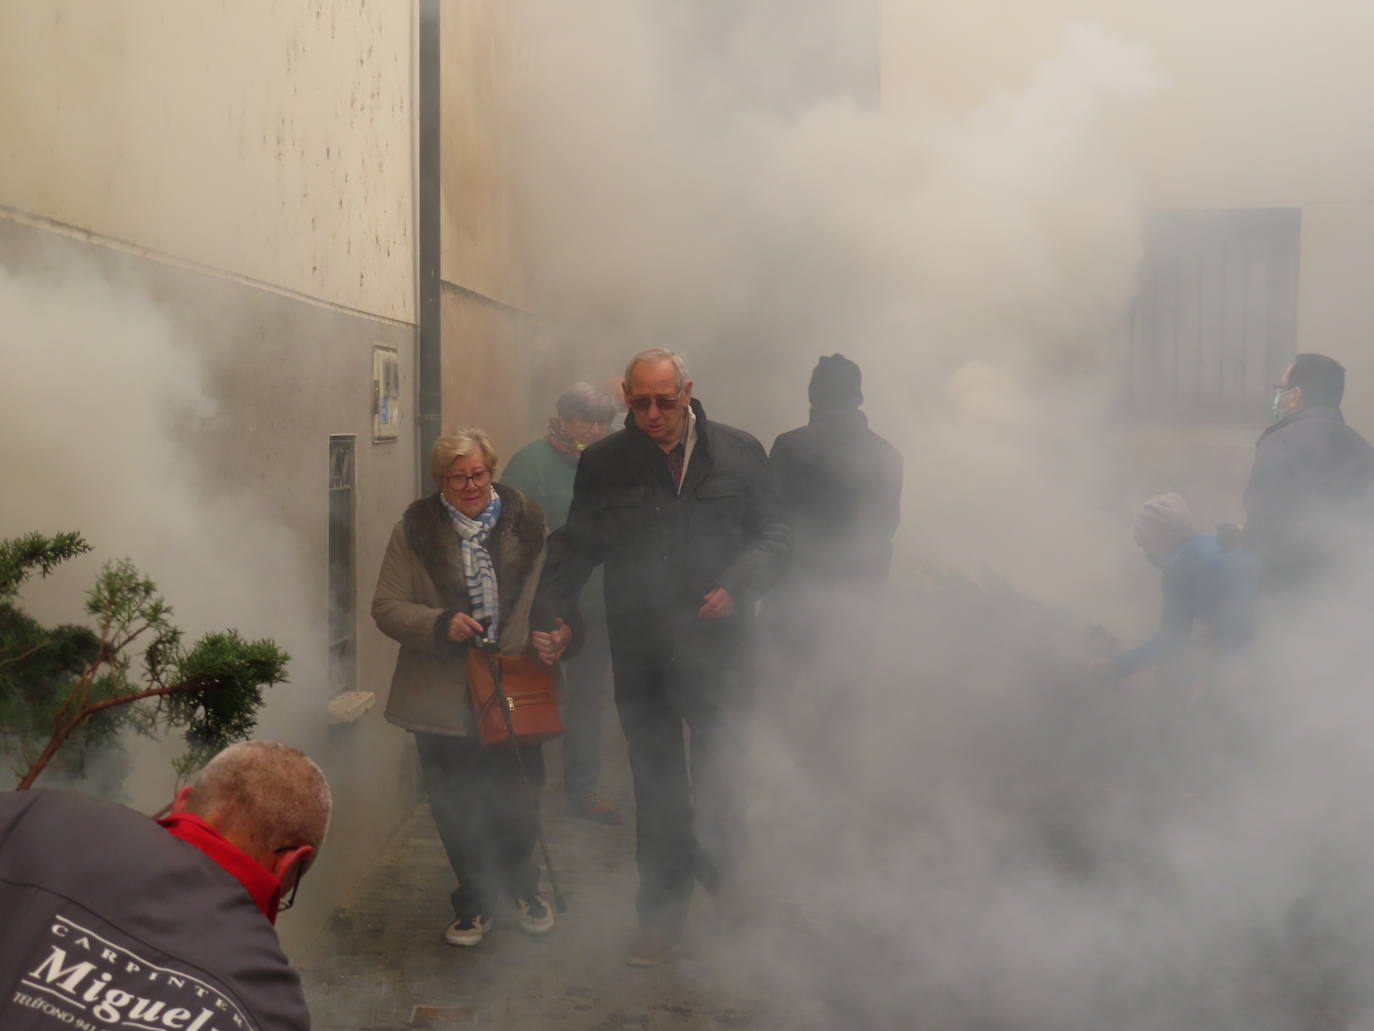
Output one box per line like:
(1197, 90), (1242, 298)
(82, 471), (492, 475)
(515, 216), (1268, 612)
(415, 734), (544, 917)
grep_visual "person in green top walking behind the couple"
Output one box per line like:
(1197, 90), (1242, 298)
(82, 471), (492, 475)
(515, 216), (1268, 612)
(502, 384), (621, 825)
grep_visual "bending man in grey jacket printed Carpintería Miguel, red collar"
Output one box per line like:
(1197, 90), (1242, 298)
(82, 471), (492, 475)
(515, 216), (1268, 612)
(0, 741), (330, 1031)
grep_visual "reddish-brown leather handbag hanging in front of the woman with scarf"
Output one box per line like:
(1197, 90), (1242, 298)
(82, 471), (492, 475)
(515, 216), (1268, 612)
(467, 645), (563, 748)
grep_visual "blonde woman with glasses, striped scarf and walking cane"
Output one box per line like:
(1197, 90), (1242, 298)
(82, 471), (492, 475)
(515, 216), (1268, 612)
(372, 429), (557, 946)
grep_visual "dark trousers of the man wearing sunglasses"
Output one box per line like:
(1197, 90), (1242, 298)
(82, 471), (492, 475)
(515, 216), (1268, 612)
(616, 661), (750, 931)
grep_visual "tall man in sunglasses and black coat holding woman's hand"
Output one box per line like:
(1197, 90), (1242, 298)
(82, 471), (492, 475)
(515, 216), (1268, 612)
(541, 348), (791, 966)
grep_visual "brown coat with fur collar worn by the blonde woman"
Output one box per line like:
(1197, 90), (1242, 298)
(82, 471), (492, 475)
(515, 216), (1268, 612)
(372, 484), (544, 737)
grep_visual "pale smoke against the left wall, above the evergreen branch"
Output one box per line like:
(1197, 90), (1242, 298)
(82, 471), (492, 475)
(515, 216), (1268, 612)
(0, 241), (319, 806)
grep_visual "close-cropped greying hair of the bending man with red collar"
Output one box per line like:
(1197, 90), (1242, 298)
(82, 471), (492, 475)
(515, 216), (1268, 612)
(187, 741), (333, 854)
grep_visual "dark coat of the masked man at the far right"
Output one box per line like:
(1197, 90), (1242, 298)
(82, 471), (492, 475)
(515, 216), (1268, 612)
(1243, 406), (1374, 579)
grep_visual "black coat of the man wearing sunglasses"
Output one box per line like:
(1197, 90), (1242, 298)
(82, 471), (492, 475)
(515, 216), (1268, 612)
(540, 400), (791, 669)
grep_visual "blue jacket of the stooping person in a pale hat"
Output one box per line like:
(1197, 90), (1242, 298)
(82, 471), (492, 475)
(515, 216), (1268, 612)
(1112, 533), (1260, 676)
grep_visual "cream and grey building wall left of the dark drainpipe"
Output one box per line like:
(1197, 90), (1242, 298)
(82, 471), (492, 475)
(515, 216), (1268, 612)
(0, 0), (418, 950)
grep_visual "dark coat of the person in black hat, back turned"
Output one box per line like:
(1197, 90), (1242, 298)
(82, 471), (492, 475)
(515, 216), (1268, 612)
(769, 408), (901, 587)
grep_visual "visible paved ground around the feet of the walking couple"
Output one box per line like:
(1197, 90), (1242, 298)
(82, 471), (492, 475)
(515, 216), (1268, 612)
(300, 733), (813, 1031)
